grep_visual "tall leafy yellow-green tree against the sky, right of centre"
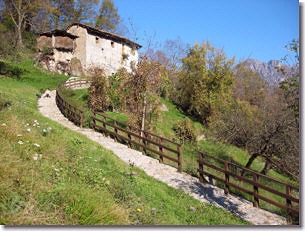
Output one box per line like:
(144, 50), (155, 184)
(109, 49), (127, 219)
(177, 43), (234, 124)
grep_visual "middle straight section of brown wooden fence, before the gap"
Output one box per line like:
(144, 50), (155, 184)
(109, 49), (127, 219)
(92, 112), (182, 172)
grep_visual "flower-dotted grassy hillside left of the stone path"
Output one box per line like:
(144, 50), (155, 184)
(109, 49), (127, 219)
(0, 56), (248, 225)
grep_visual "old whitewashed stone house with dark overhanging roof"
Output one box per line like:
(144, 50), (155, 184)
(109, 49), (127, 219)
(37, 23), (141, 76)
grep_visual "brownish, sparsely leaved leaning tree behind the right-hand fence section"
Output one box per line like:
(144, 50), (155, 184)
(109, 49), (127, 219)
(210, 91), (299, 179)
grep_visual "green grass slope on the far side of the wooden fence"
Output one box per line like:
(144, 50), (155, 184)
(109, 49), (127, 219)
(61, 80), (297, 218)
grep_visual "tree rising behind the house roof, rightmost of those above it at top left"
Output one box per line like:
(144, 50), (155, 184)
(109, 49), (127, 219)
(95, 0), (120, 32)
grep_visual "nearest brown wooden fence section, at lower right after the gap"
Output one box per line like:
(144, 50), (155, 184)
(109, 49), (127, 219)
(198, 152), (299, 218)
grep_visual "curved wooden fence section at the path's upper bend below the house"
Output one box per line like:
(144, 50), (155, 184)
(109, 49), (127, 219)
(56, 79), (90, 127)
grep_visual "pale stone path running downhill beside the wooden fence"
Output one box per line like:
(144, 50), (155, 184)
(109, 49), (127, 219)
(38, 90), (287, 225)
